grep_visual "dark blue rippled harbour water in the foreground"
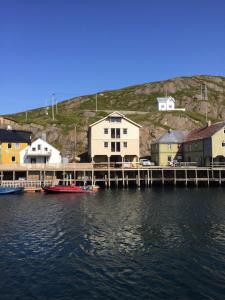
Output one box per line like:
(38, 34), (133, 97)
(0, 187), (225, 300)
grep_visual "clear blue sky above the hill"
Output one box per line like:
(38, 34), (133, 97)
(0, 0), (225, 114)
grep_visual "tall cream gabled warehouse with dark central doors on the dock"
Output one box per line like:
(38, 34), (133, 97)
(89, 111), (141, 162)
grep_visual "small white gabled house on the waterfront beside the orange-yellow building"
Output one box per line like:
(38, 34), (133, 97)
(20, 138), (62, 164)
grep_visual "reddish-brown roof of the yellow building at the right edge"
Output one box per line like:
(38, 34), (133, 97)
(184, 121), (225, 142)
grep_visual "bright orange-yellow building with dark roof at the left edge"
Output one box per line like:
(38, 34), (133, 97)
(0, 129), (31, 164)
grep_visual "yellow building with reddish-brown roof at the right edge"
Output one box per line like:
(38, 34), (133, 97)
(183, 121), (225, 166)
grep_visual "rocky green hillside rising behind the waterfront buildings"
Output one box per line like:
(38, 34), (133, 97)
(4, 75), (225, 158)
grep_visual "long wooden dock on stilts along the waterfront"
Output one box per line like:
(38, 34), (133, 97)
(0, 163), (225, 189)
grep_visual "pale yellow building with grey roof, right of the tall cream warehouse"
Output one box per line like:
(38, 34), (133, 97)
(151, 130), (186, 166)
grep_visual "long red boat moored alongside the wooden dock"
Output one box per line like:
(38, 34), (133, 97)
(42, 185), (97, 193)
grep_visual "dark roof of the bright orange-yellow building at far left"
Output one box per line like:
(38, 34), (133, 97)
(0, 129), (32, 144)
